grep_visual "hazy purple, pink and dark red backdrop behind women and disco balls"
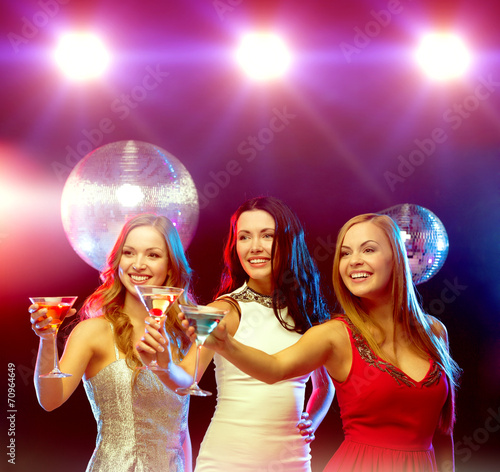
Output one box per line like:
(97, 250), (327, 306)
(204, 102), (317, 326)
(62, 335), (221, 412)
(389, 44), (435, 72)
(0, 0), (500, 472)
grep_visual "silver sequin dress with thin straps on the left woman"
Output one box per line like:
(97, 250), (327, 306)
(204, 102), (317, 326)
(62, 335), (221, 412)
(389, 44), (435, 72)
(83, 328), (189, 472)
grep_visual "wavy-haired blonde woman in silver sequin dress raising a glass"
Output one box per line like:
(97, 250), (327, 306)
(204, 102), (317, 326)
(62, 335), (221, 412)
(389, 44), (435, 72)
(30, 215), (197, 472)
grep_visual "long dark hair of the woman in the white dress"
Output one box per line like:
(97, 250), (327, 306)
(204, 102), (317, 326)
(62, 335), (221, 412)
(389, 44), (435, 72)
(217, 197), (329, 334)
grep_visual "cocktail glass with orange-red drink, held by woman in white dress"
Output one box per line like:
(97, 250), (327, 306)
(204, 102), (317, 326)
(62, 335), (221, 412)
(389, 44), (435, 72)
(135, 285), (184, 370)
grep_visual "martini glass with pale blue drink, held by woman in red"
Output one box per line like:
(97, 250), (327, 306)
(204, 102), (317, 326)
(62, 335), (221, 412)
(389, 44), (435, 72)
(175, 305), (228, 397)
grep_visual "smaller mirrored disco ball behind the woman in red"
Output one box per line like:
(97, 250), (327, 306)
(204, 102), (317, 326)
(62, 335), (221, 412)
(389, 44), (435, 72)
(380, 203), (449, 284)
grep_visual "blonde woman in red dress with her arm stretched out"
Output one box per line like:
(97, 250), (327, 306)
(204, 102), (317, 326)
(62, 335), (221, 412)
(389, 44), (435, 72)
(206, 214), (460, 472)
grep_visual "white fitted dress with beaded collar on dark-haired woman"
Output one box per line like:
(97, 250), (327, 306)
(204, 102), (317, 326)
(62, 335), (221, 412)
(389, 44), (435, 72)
(195, 285), (311, 472)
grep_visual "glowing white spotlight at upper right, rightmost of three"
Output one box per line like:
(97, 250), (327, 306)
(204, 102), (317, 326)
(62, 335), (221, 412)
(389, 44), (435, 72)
(416, 33), (470, 81)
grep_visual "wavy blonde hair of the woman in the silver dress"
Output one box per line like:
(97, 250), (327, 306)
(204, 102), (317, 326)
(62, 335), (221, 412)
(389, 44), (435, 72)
(81, 214), (194, 369)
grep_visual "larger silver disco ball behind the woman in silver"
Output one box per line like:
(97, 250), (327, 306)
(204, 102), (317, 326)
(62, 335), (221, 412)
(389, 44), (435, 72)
(61, 141), (199, 270)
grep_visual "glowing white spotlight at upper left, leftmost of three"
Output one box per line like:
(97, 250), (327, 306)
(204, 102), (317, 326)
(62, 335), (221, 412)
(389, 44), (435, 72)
(55, 33), (109, 81)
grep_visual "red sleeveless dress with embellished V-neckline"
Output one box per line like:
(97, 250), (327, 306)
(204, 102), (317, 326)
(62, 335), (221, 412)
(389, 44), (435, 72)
(325, 318), (449, 472)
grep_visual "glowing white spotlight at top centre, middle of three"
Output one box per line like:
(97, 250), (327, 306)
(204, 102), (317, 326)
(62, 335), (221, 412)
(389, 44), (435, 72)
(236, 33), (291, 81)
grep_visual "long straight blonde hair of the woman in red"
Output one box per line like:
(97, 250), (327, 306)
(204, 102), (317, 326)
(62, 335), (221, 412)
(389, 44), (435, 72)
(333, 213), (461, 433)
